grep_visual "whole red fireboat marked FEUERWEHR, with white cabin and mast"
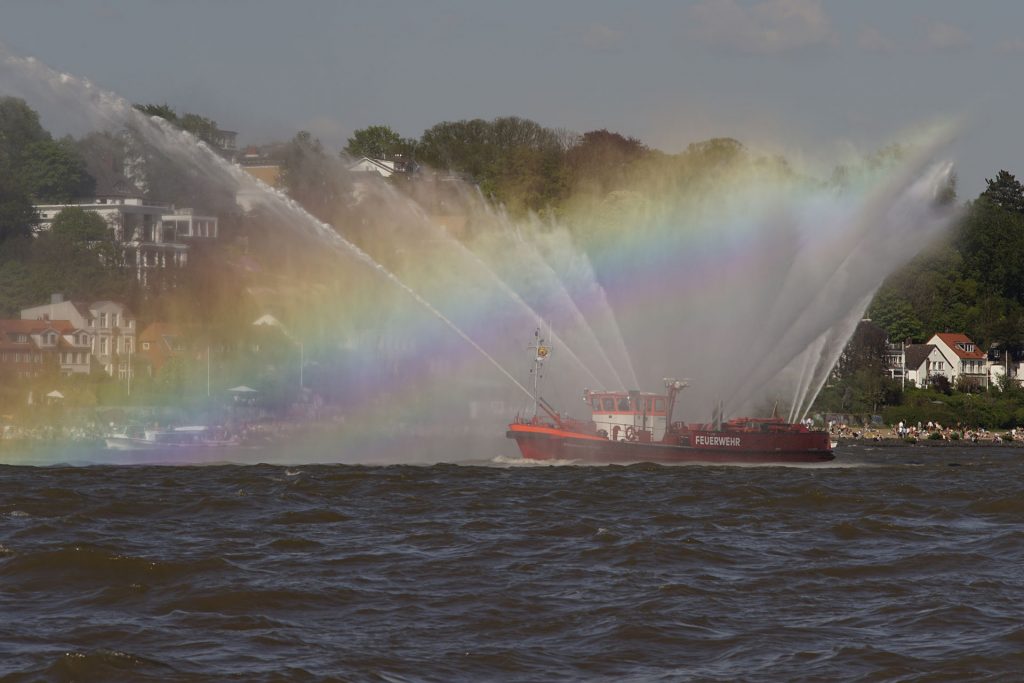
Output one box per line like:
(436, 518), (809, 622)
(505, 333), (836, 464)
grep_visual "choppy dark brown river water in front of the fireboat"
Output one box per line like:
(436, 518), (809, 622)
(0, 449), (1024, 681)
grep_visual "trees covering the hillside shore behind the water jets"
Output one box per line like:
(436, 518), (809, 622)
(0, 97), (1024, 360)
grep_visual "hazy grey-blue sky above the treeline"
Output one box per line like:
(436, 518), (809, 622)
(0, 0), (1024, 197)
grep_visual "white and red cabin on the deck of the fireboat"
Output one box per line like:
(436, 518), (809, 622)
(583, 389), (669, 441)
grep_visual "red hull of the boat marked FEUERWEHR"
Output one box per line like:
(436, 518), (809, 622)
(506, 422), (835, 463)
